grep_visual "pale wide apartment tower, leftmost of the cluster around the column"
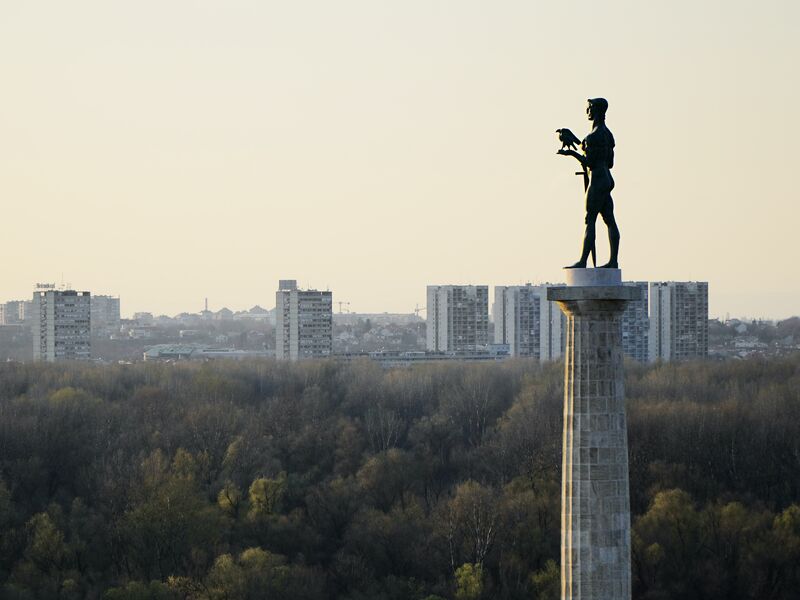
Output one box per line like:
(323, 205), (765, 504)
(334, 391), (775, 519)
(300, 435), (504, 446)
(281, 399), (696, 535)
(426, 285), (489, 352)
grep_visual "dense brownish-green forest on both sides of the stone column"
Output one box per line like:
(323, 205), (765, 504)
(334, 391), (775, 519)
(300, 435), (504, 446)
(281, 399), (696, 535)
(0, 357), (800, 600)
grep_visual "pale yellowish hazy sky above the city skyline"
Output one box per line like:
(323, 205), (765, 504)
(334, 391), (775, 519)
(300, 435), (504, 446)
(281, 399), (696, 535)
(0, 0), (800, 317)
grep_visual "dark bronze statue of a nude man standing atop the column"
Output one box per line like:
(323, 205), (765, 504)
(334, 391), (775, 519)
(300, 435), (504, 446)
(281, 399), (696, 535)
(558, 98), (619, 269)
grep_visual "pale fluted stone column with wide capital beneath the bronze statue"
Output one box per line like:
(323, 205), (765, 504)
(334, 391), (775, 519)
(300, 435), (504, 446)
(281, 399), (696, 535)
(547, 269), (639, 600)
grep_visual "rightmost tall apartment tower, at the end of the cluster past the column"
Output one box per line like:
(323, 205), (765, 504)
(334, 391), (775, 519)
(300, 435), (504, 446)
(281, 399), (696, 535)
(650, 281), (708, 361)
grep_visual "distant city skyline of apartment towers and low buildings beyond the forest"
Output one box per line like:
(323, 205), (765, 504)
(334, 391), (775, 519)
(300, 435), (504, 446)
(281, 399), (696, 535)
(0, 278), (760, 366)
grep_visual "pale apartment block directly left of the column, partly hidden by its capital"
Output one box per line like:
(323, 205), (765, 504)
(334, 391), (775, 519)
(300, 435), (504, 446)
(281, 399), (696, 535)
(493, 284), (565, 360)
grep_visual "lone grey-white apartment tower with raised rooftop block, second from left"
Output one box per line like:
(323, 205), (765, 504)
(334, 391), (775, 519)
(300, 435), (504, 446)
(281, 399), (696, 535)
(275, 279), (333, 360)
